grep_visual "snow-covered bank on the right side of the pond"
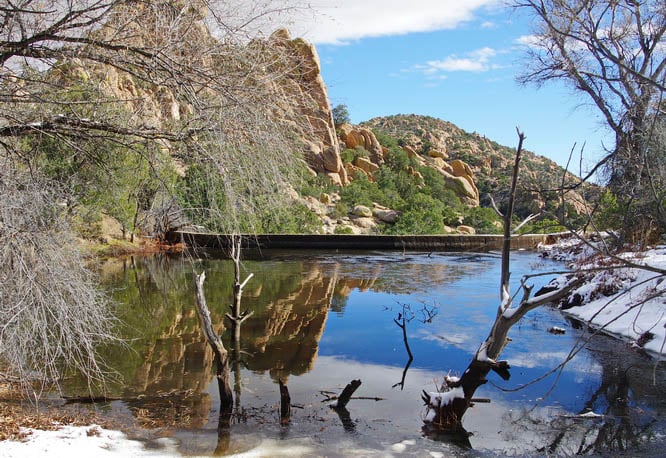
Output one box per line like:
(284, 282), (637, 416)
(548, 240), (666, 355)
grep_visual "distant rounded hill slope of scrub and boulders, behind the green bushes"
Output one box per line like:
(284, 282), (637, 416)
(362, 115), (589, 220)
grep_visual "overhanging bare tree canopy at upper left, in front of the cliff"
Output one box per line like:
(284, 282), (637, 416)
(0, 0), (307, 229)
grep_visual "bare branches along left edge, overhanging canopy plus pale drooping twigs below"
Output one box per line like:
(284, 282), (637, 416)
(0, 0), (306, 392)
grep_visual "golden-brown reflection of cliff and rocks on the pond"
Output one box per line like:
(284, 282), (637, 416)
(94, 256), (466, 414)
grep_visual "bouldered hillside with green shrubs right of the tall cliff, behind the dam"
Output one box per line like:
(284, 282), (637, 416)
(300, 115), (591, 234)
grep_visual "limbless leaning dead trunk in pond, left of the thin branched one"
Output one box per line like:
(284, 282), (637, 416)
(194, 272), (234, 426)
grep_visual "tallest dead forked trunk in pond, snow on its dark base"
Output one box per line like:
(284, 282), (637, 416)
(423, 131), (575, 440)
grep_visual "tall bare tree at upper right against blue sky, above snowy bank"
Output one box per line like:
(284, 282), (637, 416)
(513, 0), (666, 243)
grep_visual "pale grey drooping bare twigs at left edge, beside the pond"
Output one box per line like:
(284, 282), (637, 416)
(0, 166), (116, 397)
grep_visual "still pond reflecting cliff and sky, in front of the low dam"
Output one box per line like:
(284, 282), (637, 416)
(66, 251), (666, 457)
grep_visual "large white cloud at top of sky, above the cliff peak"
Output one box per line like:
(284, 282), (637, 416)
(272, 0), (499, 44)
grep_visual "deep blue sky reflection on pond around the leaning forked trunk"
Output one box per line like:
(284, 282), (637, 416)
(319, 253), (600, 409)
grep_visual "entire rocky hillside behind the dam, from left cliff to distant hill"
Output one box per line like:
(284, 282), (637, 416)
(6, 8), (583, 241)
